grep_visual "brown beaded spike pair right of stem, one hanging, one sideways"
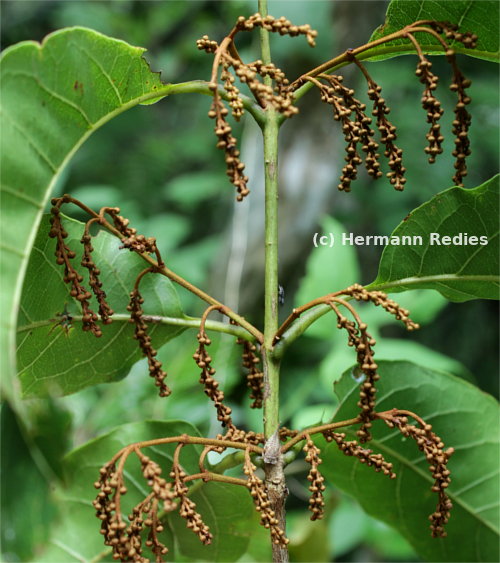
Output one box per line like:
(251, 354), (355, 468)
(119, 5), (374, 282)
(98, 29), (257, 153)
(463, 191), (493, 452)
(326, 284), (418, 442)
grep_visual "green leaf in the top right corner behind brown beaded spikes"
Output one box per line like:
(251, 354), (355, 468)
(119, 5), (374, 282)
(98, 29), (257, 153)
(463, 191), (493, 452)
(363, 0), (499, 62)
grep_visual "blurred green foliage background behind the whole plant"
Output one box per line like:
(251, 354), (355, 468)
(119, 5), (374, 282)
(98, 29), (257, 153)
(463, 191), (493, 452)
(1, 0), (499, 562)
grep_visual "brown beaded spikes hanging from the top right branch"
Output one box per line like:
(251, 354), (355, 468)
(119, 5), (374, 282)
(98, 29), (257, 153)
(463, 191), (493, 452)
(302, 21), (477, 191)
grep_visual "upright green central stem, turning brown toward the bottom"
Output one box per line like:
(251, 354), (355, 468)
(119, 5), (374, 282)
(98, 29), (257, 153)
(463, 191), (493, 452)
(259, 0), (288, 563)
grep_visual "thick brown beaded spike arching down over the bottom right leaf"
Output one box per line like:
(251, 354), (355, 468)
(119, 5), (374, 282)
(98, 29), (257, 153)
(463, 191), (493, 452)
(381, 409), (454, 538)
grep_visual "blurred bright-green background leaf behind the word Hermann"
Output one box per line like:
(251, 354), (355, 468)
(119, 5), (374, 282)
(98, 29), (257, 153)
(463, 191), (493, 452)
(295, 216), (361, 338)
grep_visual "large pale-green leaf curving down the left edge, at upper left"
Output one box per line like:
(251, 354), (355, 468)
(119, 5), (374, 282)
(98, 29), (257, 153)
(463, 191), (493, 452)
(0, 28), (168, 395)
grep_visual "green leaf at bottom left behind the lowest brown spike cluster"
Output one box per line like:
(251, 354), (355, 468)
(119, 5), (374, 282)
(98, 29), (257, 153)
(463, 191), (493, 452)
(37, 421), (258, 563)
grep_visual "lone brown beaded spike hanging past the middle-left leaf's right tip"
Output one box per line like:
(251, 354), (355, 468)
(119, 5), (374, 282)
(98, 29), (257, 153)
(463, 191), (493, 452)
(127, 268), (171, 397)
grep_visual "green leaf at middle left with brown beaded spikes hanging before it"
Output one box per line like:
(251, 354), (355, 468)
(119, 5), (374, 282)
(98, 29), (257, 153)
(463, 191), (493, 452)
(17, 215), (184, 397)
